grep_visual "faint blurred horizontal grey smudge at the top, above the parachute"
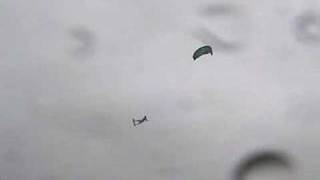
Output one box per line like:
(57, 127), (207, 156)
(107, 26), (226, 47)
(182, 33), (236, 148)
(200, 4), (238, 16)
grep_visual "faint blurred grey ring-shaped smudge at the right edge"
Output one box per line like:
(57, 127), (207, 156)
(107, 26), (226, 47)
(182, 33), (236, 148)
(294, 11), (320, 44)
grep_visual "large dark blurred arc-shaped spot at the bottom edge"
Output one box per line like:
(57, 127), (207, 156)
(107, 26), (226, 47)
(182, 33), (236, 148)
(234, 151), (293, 180)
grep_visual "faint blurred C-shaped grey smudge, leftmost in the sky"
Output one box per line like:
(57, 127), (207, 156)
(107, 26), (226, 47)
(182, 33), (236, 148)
(70, 26), (96, 57)
